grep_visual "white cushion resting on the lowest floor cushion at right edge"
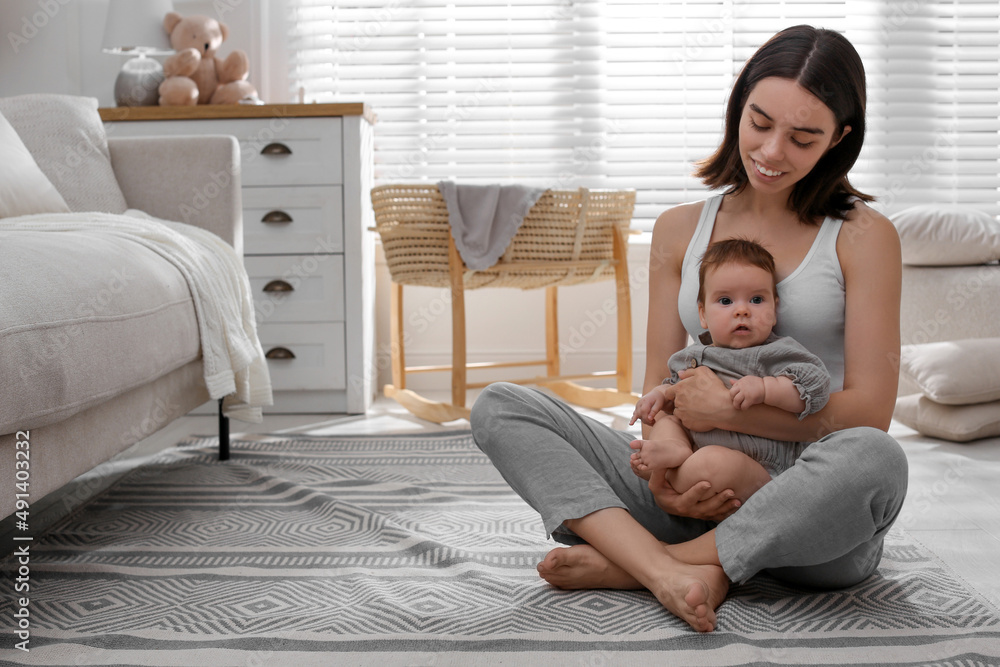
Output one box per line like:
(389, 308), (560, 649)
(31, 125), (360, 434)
(899, 338), (1000, 405)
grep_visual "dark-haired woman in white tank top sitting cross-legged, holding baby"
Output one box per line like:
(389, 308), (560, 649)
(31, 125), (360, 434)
(471, 26), (907, 631)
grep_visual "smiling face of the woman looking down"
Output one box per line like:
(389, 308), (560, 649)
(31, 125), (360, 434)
(739, 77), (851, 193)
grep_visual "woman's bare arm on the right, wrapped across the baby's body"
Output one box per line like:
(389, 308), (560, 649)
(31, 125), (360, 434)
(674, 203), (902, 441)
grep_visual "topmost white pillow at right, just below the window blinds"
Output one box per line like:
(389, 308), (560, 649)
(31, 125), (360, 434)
(891, 204), (1000, 266)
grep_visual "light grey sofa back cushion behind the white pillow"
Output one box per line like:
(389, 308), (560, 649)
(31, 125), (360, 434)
(0, 94), (127, 213)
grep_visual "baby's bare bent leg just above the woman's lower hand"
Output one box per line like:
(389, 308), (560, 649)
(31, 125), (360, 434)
(667, 445), (771, 502)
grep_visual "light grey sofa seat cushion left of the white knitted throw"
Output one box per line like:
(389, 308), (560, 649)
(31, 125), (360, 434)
(0, 230), (200, 433)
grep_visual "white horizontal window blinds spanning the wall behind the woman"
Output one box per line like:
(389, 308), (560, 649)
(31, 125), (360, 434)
(281, 0), (1000, 229)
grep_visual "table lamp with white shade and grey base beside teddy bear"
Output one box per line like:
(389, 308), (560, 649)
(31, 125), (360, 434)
(101, 0), (174, 107)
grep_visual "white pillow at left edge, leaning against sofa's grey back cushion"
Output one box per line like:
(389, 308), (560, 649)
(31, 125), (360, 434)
(0, 115), (69, 218)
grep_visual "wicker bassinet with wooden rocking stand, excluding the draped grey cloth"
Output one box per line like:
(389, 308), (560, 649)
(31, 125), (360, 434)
(371, 185), (638, 423)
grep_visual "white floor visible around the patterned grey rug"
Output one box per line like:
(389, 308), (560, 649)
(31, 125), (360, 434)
(21, 394), (1000, 607)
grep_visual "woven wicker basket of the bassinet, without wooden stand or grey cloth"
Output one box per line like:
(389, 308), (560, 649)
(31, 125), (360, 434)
(372, 185), (635, 289)
